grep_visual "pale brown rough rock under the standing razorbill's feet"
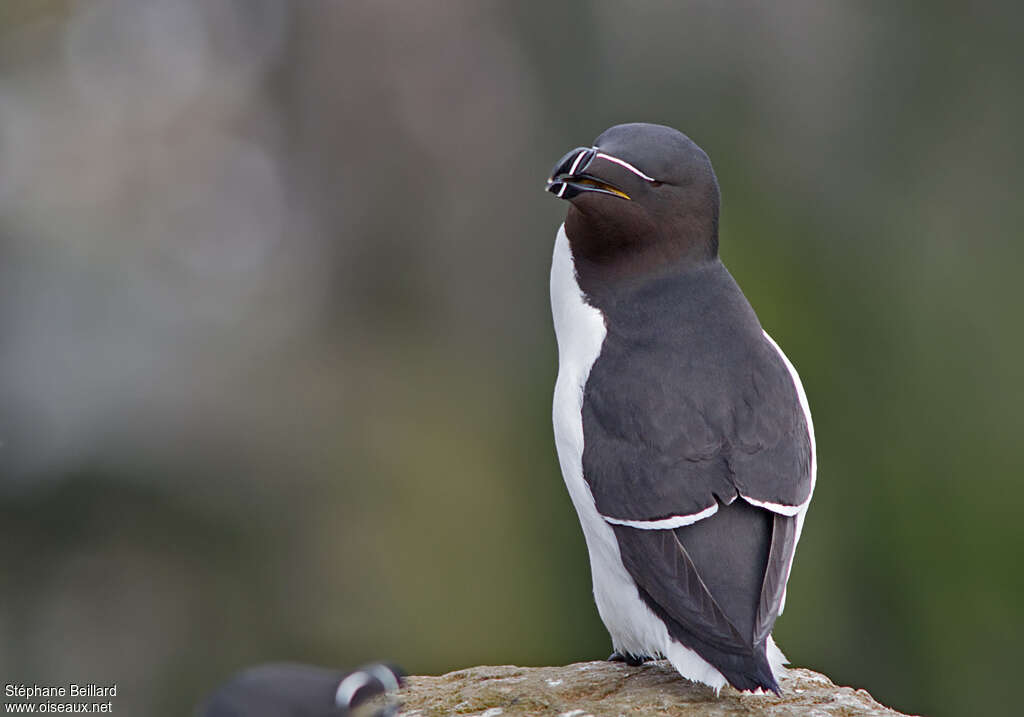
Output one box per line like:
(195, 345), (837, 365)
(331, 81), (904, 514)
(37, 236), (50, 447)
(382, 661), (913, 717)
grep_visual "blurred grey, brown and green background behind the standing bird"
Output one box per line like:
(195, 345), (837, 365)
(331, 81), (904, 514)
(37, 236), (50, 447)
(0, 0), (1024, 717)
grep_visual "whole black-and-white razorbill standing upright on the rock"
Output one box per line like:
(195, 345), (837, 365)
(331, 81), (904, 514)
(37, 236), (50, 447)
(546, 123), (817, 694)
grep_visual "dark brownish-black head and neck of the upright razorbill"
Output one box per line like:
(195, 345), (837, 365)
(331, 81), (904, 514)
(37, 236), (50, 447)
(548, 123), (720, 291)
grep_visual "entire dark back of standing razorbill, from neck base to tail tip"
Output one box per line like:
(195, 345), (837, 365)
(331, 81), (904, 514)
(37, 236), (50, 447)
(583, 264), (811, 690)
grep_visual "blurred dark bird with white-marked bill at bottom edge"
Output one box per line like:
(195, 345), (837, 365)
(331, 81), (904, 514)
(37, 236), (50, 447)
(195, 663), (404, 717)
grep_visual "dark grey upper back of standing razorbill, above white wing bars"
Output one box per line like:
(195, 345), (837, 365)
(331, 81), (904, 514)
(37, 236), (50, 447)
(583, 264), (811, 521)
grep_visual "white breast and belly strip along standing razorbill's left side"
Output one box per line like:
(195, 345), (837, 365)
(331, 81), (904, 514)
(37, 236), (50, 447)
(551, 225), (725, 689)
